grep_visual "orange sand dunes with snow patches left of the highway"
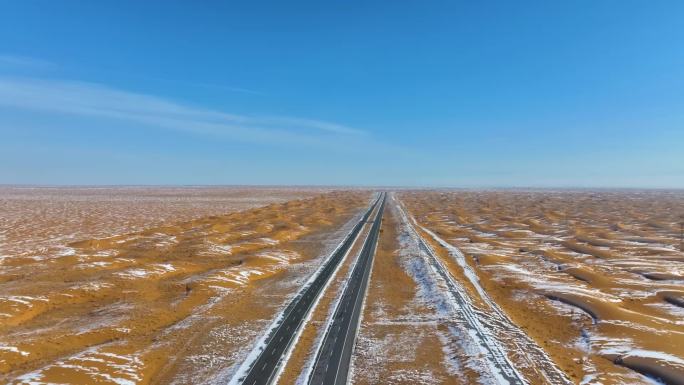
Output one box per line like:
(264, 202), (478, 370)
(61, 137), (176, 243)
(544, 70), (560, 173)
(0, 188), (368, 383)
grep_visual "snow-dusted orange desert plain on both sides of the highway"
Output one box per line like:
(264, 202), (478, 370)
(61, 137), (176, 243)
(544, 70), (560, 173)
(0, 186), (684, 385)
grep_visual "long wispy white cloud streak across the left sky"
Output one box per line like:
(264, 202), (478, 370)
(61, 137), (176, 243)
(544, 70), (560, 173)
(0, 77), (365, 143)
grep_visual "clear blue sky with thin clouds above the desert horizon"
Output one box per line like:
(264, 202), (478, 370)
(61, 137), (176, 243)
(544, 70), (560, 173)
(0, 0), (684, 188)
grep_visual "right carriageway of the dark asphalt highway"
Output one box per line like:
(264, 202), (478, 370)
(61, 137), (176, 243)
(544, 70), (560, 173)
(309, 193), (385, 385)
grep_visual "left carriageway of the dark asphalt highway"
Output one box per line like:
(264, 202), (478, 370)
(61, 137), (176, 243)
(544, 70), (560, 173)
(239, 194), (384, 385)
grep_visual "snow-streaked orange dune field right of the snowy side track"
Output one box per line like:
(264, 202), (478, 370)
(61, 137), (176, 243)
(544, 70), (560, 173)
(401, 191), (684, 384)
